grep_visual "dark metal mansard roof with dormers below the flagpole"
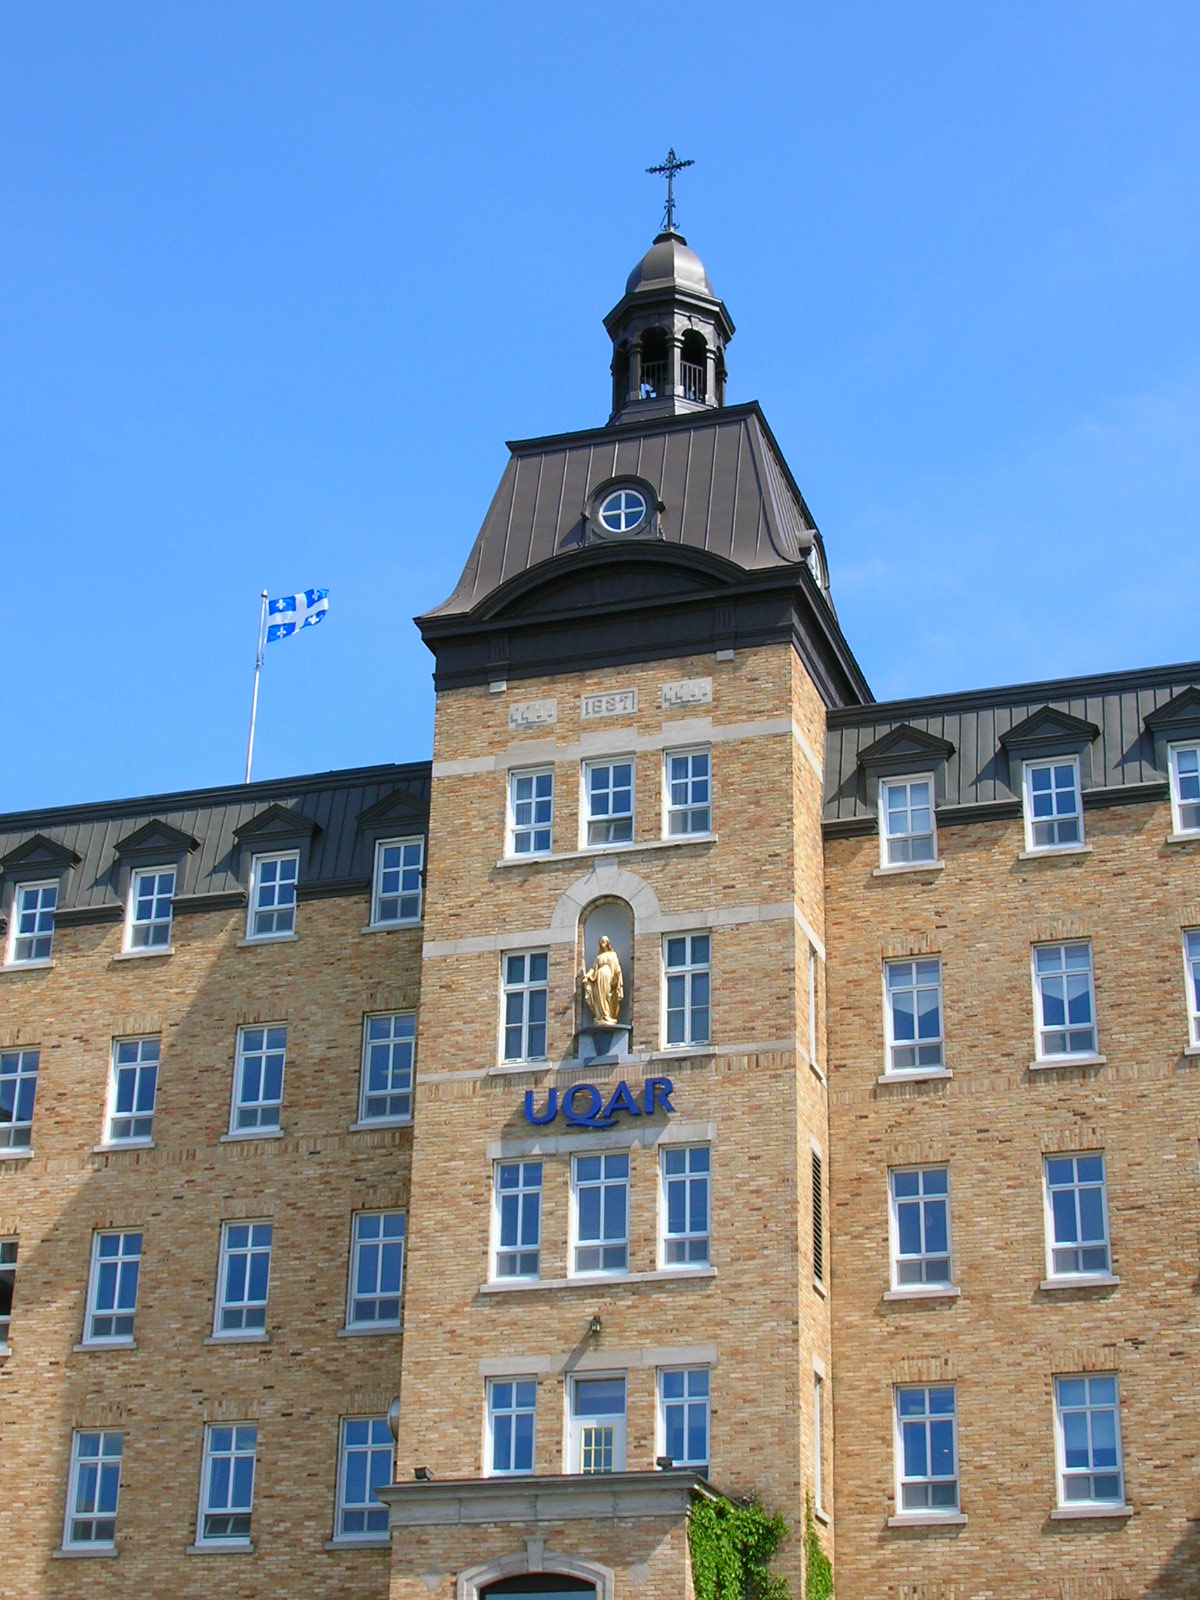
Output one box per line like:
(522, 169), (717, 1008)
(0, 762), (430, 920)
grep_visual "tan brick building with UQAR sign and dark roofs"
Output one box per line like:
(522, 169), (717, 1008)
(0, 216), (1200, 1600)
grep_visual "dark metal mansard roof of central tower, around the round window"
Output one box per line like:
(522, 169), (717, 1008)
(427, 402), (816, 618)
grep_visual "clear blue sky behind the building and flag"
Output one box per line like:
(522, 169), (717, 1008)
(0, 0), (1200, 810)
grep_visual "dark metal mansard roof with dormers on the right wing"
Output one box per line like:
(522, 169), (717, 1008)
(824, 661), (1200, 834)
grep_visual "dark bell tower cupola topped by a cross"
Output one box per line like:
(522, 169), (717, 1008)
(605, 150), (734, 424)
